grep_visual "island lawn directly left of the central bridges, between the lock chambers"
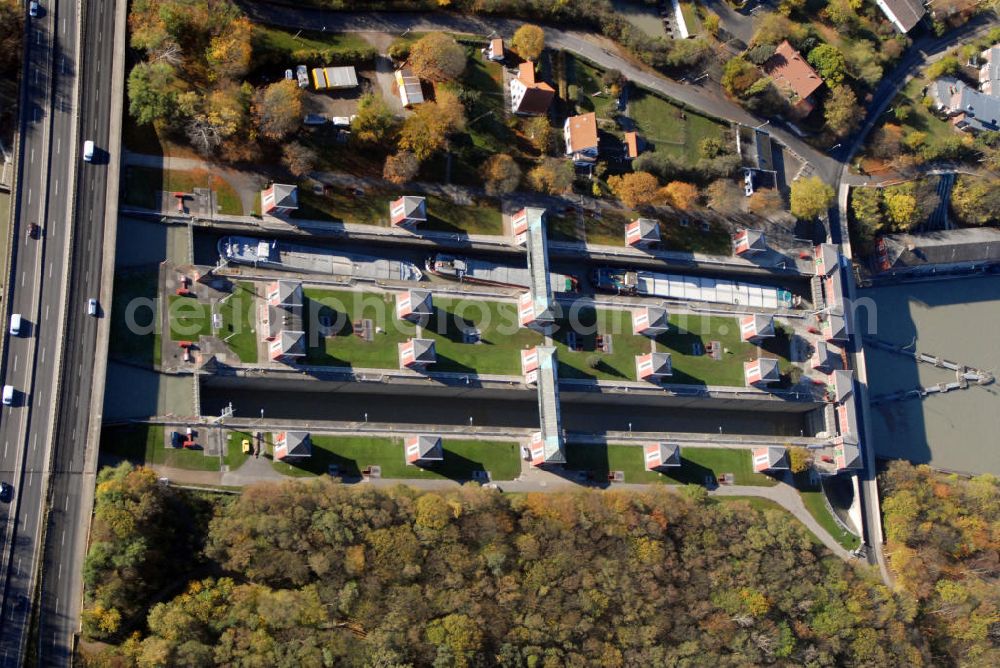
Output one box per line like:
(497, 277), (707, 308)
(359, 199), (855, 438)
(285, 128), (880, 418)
(423, 298), (542, 376)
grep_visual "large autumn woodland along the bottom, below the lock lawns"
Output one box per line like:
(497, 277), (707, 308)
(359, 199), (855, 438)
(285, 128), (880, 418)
(85, 464), (927, 666)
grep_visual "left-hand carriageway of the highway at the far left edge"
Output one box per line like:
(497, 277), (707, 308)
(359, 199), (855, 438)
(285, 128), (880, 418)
(0, 0), (79, 666)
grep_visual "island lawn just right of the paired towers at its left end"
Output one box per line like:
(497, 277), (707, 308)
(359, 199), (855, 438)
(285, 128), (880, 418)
(304, 289), (414, 369)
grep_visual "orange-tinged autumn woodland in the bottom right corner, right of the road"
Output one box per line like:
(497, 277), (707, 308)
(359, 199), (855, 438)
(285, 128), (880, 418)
(881, 462), (1000, 666)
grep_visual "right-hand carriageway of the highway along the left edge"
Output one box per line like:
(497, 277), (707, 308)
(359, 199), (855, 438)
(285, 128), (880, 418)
(38, 0), (121, 665)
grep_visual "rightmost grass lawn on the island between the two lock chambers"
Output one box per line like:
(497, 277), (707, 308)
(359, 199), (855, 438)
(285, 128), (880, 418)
(656, 314), (758, 387)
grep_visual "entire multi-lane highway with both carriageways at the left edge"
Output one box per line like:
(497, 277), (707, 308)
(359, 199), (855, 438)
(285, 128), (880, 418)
(0, 0), (115, 666)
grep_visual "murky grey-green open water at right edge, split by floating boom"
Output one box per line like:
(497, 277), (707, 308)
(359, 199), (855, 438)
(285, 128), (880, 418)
(857, 277), (1000, 475)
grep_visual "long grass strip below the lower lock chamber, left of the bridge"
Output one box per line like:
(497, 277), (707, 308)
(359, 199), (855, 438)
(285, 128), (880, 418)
(273, 436), (521, 480)
